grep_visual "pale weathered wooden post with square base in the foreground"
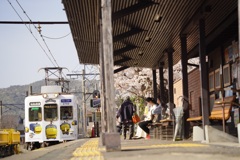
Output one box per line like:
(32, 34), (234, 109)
(101, 0), (121, 151)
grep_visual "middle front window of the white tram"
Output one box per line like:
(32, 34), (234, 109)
(44, 104), (58, 121)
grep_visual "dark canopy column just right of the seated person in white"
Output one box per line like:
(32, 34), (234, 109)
(166, 48), (174, 118)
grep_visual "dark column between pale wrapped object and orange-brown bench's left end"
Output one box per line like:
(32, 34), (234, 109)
(180, 35), (190, 139)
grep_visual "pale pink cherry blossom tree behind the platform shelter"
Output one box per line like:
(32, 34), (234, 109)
(114, 58), (199, 115)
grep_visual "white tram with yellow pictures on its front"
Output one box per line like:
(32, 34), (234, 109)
(25, 86), (78, 150)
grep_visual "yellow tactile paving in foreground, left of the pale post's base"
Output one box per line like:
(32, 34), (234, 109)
(71, 139), (104, 160)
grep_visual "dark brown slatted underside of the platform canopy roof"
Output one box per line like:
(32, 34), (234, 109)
(62, 0), (237, 68)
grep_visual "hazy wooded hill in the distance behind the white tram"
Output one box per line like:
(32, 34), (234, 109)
(0, 80), (99, 128)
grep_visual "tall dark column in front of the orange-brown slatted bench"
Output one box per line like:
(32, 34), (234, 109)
(199, 18), (209, 140)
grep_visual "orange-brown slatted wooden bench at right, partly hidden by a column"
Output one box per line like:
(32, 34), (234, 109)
(187, 96), (236, 130)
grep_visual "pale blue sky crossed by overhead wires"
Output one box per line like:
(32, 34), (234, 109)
(0, 0), (81, 88)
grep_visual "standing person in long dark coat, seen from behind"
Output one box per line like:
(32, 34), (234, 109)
(116, 96), (135, 139)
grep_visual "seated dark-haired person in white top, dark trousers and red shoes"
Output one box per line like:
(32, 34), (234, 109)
(138, 97), (161, 139)
